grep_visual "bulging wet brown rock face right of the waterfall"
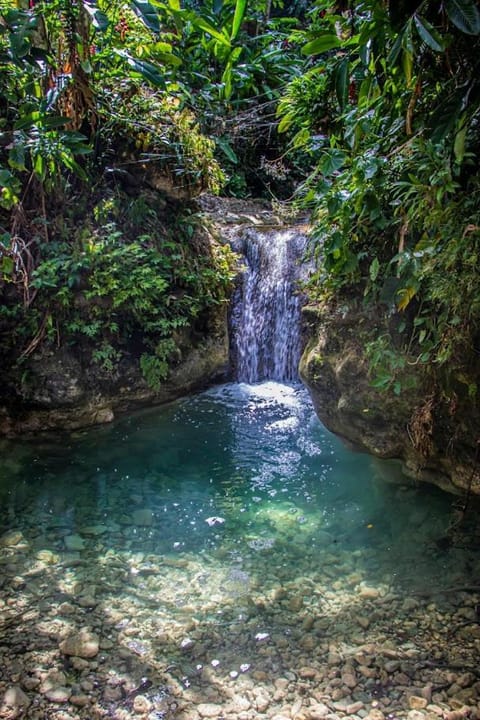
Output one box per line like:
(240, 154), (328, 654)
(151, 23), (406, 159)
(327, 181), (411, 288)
(300, 306), (480, 494)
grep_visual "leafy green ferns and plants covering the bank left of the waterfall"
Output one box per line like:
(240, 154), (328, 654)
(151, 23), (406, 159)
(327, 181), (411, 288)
(0, 188), (234, 380)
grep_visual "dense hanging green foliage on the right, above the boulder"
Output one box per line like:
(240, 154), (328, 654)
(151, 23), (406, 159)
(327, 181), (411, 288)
(284, 0), (480, 392)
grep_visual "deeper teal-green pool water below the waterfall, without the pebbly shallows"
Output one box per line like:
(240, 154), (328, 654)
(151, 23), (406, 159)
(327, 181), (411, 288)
(0, 382), (469, 608)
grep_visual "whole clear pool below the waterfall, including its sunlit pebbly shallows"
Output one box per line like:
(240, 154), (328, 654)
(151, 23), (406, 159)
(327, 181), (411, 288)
(0, 382), (480, 717)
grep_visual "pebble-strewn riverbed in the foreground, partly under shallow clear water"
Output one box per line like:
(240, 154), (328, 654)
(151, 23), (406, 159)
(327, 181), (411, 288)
(0, 524), (480, 720)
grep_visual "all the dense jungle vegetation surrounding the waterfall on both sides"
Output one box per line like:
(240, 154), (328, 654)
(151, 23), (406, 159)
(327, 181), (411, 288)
(0, 0), (480, 402)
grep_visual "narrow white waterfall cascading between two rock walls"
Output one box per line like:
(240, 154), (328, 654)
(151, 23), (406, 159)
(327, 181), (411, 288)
(230, 228), (306, 383)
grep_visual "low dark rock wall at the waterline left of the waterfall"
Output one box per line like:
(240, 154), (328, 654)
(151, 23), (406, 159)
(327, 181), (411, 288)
(0, 305), (228, 436)
